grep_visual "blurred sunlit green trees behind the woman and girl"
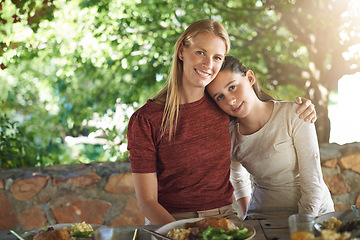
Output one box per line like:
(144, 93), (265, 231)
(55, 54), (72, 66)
(0, 0), (360, 168)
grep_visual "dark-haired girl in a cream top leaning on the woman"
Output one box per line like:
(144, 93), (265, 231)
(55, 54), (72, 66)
(207, 56), (334, 219)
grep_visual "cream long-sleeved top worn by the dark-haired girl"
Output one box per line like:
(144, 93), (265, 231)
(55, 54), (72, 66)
(229, 101), (334, 219)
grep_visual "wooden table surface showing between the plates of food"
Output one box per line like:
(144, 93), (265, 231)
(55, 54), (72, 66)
(0, 219), (290, 240)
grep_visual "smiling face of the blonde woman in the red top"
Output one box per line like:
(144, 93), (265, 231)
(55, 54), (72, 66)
(179, 33), (226, 88)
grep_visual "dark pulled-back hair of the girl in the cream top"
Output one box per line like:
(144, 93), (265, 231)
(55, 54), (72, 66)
(220, 55), (275, 102)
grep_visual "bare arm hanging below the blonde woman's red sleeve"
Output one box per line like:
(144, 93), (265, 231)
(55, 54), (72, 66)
(132, 173), (175, 225)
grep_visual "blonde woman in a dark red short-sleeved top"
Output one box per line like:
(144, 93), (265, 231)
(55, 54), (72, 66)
(127, 20), (316, 224)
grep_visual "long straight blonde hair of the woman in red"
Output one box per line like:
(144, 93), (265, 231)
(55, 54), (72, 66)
(154, 19), (230, 139)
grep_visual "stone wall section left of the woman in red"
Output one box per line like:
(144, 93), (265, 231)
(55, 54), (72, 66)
(0, 162), (144, 230)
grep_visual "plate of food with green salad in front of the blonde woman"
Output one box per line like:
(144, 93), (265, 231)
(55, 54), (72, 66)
(152, 218), (256, 240)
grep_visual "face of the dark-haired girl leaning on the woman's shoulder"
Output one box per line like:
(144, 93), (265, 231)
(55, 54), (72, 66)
(206, 70), (256, 118)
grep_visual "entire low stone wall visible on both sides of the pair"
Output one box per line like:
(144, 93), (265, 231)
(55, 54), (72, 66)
(0, 143), (360, 230)
